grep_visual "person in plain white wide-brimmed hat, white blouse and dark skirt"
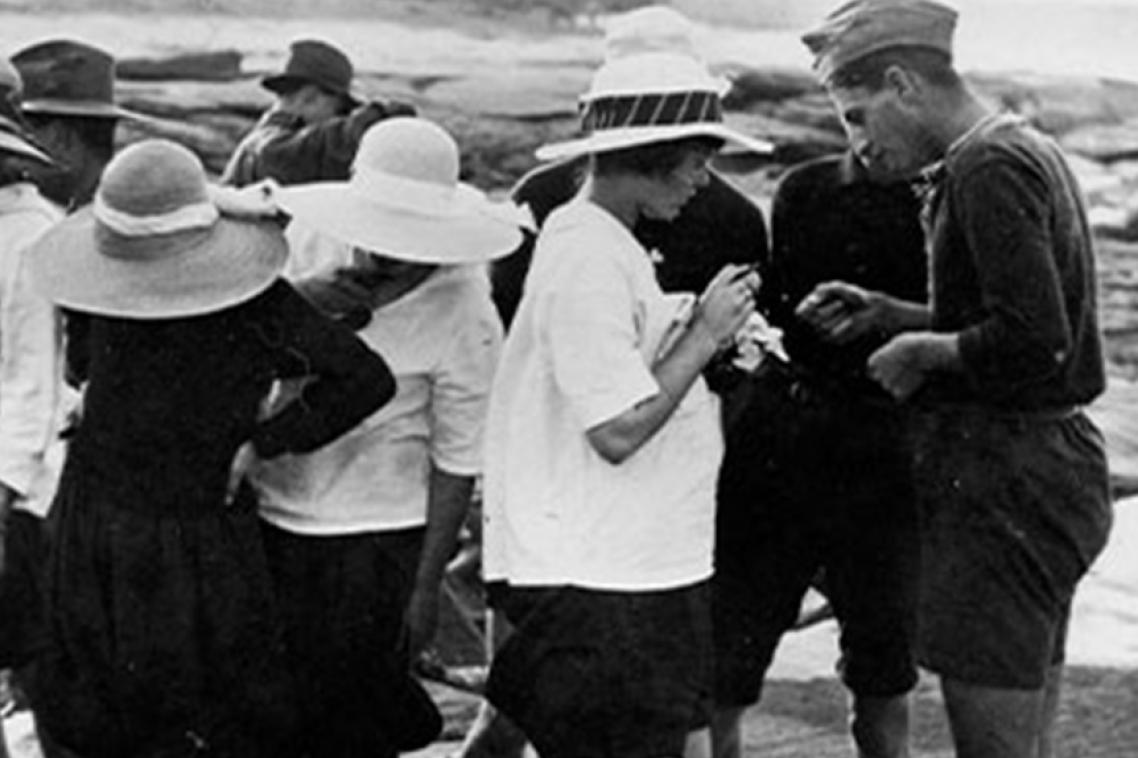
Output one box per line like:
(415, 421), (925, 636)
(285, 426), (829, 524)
(246, 117), (521, 757)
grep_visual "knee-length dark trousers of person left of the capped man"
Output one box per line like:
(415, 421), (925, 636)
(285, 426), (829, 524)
(712, 364), (918, 706)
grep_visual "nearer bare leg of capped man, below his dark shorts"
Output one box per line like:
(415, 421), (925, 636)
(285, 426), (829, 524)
(940, 677), (1045, 758)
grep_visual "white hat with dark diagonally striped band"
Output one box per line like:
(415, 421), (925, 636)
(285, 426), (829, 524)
(537, 6), (774, 160)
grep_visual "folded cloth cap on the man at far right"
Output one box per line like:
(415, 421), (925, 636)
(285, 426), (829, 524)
(802, 0), (957, 81)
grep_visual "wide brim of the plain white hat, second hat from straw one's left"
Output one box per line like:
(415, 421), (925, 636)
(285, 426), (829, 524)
(277, 182), (522, 265)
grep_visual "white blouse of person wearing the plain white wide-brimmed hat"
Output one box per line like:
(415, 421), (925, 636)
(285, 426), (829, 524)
(254, 225), (502, 535)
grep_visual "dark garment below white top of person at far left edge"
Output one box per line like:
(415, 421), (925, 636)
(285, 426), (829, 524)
(0, 510), (48, 668)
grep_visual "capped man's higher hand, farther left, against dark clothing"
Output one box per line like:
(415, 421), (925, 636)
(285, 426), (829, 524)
(794, 281), (892, 344)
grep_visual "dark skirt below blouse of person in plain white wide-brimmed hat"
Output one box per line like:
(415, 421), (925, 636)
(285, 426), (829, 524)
(263, 524), (442, 758)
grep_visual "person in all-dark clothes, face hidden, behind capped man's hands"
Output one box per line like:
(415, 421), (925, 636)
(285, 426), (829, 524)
(712, 154), (926, 758)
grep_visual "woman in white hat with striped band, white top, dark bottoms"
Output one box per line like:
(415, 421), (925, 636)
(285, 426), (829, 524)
(475, 5), (769, 758)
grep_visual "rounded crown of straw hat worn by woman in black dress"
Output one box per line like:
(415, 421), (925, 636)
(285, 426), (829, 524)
(98, 139), (208, 217)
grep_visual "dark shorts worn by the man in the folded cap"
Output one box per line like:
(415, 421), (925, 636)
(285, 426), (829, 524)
(914, 412), (1112, 690)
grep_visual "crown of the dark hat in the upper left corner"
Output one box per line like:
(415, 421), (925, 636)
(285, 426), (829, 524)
(11, 40), (115, 105)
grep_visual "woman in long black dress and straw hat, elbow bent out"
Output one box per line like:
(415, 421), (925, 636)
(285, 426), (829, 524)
(30, 140), (395, 758)
